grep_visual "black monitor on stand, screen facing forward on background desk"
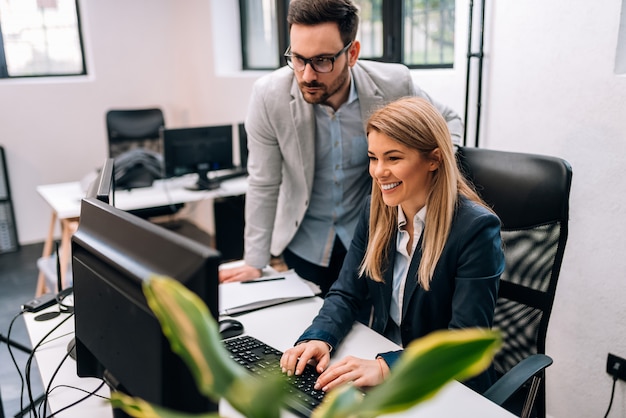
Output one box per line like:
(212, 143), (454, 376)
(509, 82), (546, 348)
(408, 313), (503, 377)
(162, 125), (234, 190)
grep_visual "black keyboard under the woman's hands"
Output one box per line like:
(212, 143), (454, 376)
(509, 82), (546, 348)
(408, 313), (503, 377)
(224, 335), (324, 417)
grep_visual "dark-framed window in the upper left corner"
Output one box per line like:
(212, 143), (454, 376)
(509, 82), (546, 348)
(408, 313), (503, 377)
(0, 0), (87, 78)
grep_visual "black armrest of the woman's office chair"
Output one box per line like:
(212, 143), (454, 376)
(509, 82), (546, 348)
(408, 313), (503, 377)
(483, 354), (552, 405)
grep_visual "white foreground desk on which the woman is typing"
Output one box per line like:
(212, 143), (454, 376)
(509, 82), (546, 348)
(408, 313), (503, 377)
(25, 298), (514, 418)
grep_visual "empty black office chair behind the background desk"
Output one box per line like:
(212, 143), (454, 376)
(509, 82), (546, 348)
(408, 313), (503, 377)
(106, 108), (184, 218)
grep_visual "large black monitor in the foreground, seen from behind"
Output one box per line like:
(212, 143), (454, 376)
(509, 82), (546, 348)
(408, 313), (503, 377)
(72, 158), (221, 413)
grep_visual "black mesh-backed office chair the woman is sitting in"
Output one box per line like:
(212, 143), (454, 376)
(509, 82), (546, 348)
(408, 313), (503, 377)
(458, 148), (572, 417)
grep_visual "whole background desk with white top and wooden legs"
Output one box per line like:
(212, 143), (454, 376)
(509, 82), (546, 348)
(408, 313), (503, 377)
(35, 174), (248, 296)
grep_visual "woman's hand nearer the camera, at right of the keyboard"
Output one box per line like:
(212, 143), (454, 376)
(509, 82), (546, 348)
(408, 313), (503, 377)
(315, 356), (388, 392)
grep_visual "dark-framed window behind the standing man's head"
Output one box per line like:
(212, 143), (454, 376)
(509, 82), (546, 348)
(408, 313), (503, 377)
(239, 0), (455, 69)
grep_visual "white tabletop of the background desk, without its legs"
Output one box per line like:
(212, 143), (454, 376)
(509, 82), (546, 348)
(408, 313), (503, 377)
(37, 174), (248, 219)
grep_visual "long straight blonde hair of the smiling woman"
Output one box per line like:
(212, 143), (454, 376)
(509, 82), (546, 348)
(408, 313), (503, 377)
(359, 97), (487, 290)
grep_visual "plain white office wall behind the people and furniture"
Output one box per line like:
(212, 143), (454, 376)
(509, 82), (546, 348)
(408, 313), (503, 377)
(0, 0), (626, 418)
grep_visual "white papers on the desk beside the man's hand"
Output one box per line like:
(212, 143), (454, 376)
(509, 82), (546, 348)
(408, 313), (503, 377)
(219, 270), (315, 315)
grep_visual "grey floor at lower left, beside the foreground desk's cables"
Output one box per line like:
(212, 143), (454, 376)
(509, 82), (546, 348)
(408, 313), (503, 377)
(0, 243), (43, 418)
